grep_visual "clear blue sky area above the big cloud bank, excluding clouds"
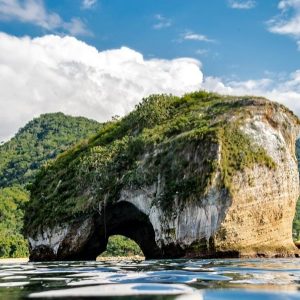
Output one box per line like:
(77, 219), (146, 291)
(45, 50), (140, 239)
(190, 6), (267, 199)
(0, 0), (299, 80)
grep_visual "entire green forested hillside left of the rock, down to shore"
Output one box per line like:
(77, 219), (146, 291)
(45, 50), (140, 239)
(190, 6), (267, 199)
(0, 113), (101, 257)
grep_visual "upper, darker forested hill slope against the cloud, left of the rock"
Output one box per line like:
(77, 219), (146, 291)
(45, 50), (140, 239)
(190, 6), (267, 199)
(0, 113), (100, 187)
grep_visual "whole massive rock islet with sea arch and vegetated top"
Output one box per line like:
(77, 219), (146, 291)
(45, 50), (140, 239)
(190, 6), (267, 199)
(25, 92), (299, 260)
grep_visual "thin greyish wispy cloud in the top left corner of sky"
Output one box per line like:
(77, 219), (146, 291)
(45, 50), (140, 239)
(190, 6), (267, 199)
(0, 0), (90, 35)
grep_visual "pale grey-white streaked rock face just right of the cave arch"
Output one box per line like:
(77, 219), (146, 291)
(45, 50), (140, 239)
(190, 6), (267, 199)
(120, 171), (230, 248)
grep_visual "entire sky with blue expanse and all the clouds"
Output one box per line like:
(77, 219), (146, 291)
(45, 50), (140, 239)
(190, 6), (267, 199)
(0, 0), (300, 142)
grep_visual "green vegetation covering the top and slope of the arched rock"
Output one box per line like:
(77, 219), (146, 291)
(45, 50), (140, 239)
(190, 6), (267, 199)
(26, 91), (286, 233)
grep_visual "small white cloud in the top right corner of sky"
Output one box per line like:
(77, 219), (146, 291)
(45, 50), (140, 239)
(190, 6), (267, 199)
(268, 0), (300, 39)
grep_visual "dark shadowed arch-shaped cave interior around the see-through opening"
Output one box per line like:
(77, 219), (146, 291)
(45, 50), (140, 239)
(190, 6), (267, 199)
(78, 201), (162, 260)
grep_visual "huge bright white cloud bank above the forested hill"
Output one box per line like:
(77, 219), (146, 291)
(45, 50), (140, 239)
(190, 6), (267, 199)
(0, 33), (203, 141)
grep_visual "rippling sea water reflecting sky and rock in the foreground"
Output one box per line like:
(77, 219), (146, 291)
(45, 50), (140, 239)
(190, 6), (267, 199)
(0, 259), (300, 300)
